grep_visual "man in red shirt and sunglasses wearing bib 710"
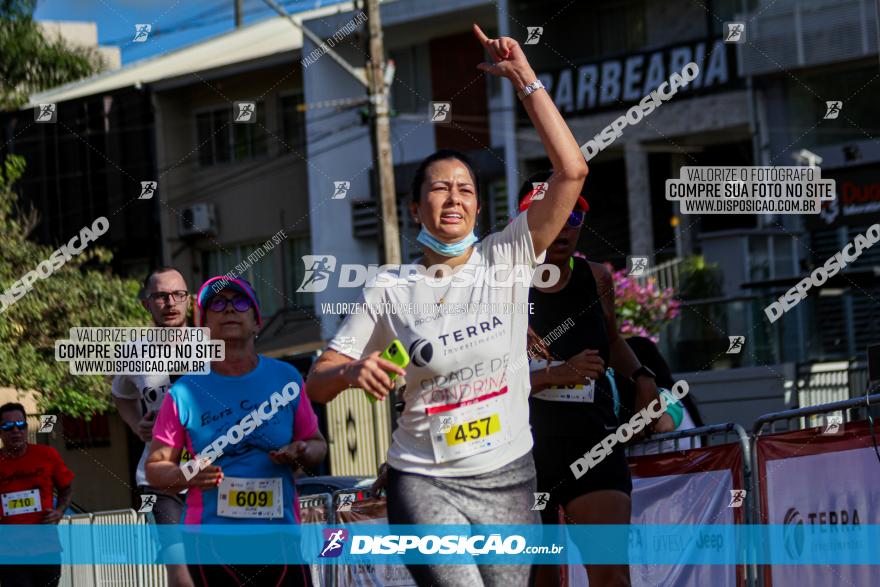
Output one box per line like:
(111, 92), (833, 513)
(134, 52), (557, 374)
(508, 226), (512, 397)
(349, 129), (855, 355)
(0, 403), (73, 587)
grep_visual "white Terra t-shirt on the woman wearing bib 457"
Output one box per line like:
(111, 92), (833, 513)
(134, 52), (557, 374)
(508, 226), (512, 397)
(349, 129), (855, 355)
(329, 214), (544, 477)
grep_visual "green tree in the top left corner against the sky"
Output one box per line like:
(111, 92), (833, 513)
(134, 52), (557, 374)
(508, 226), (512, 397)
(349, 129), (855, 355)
(0, 0), (106, 110)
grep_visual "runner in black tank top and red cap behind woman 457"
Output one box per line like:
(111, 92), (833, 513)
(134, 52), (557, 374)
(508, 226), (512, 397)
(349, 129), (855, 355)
(519, 172), (672, 587)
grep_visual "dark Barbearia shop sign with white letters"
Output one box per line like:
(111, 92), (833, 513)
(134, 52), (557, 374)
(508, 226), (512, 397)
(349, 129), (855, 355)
(538, 39), (741, 115)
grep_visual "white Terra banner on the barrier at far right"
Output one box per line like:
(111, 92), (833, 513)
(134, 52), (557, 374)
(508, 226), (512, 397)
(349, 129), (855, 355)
(766, 448), (880, 587)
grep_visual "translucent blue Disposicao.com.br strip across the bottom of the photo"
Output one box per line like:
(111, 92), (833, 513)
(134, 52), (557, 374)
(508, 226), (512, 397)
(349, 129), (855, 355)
(0, 524), (880, 565)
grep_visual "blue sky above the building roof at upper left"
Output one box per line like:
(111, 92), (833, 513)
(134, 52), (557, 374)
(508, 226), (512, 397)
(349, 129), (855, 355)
(34, 0), (334, 65)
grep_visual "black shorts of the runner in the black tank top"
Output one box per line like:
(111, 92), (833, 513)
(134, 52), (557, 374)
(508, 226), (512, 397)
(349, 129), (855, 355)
(529, 389), (632, 524)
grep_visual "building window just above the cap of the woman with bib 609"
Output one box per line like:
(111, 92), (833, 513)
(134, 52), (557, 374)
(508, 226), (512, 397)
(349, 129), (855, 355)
(203, 240), (279, 322)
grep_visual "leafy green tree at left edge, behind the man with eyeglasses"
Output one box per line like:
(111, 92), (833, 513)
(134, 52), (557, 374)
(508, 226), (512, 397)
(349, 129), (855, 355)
(0, 155), (149, 418)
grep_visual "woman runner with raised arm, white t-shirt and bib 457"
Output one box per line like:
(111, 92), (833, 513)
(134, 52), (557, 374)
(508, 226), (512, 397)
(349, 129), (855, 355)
(306, 25), (587, 587)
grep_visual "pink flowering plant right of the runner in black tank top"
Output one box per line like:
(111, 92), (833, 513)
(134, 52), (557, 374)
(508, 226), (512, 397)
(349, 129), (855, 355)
(605, 263), (681, 343)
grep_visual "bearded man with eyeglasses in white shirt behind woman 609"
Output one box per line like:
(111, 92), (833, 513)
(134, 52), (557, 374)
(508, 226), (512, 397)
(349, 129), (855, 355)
(112, 267), (193, 587)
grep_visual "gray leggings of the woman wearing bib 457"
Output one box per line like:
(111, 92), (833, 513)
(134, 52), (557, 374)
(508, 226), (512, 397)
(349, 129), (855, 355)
(386, 452), (541, 587)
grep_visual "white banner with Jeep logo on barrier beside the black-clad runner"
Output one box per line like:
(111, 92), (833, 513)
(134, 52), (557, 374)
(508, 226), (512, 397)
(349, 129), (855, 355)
(568, 470), (736, 587)
